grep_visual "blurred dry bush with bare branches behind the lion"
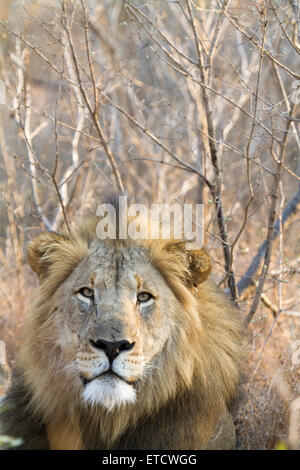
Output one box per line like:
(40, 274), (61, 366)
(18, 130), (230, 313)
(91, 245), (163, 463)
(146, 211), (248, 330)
(0, 0), (300, 449)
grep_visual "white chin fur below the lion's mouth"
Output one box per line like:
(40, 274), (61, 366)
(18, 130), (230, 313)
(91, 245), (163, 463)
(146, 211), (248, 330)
(82, 377), (136, 411)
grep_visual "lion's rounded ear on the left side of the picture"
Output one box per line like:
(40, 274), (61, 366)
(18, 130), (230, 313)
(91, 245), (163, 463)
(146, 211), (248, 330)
(27, 232), (68, 281)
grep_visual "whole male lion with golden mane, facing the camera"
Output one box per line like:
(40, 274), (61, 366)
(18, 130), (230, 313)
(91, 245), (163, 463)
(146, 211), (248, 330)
(1, 201), (243, 450)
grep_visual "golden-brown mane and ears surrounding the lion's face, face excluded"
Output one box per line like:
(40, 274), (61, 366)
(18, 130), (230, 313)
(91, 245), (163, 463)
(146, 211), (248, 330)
(1, 207), (242, 449)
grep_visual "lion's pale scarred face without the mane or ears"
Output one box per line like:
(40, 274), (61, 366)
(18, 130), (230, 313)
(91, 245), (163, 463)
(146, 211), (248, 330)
(54, 241), (178, 409)
